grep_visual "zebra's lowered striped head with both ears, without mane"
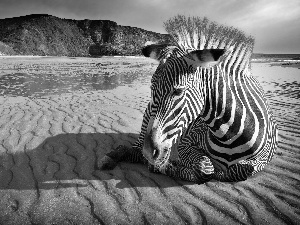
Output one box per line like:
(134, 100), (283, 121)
(142, 44), (227, 167)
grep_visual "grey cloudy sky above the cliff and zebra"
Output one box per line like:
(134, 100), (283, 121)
(0, 0), (300, 54)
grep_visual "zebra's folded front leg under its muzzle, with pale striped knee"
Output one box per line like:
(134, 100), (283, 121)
(160, 156), (214, 184)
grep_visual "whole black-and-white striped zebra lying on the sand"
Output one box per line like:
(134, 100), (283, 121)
(98, 16), (278, 184)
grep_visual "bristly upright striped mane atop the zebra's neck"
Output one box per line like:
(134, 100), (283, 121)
(164, 15), (254, 69)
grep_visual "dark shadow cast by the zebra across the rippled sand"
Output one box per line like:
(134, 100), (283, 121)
(0, 133), (202, 190)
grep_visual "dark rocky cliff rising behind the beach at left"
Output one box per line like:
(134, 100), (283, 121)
(0, 14), (171, 56)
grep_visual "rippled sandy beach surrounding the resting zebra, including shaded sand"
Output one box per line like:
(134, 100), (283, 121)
(0, 57), (300, 225)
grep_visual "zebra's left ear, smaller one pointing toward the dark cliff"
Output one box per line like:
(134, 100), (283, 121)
(142, 44), (176, 62)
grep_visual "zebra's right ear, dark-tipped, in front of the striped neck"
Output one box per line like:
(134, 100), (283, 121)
(187, 49), (226, 68)
